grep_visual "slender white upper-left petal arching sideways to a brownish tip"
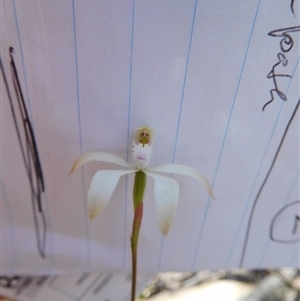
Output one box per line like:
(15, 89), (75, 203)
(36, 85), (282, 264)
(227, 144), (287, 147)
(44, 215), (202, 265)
(70, 152), (131, 174)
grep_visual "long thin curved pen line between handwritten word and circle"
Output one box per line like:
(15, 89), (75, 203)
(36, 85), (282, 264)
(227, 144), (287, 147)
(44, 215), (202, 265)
(239, 99), (300, 268)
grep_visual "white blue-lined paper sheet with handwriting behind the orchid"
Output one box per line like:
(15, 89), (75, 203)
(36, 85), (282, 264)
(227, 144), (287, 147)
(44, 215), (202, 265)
(1, 0), (300, 274)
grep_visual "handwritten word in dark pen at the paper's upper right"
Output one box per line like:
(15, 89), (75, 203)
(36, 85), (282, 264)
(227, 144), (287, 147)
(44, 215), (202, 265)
(262, 26), (300, 111)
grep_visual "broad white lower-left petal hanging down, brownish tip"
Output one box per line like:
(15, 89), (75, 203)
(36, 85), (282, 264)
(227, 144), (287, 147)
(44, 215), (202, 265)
(88, 170), (135, 220)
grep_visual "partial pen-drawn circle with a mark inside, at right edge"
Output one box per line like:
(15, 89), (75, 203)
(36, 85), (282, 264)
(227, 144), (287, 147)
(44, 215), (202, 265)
(269, 201), (300, 244)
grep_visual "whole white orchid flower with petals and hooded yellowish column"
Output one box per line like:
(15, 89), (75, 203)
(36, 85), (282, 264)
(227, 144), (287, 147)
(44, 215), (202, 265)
(70, 126), (213, 235)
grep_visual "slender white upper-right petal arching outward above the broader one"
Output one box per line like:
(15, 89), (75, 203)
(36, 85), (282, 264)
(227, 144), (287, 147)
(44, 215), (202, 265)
(151, 164), (214, 198)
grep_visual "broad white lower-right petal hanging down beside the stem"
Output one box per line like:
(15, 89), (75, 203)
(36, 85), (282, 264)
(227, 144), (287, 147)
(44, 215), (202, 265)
(145, 171), (179, 235)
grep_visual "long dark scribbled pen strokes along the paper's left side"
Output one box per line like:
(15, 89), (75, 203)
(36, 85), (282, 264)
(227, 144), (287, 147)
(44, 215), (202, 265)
(0, 47), (47, 258)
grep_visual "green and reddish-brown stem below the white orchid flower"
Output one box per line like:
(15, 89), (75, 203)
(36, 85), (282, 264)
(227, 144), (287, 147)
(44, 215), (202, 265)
(131, 170), (146, 301)
